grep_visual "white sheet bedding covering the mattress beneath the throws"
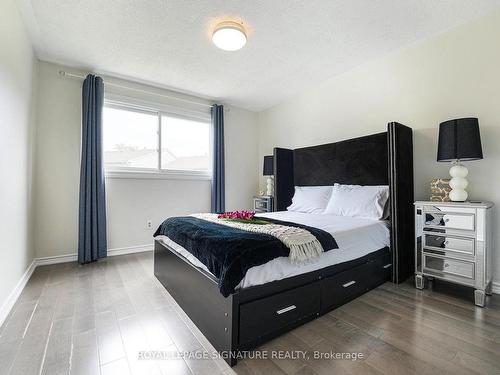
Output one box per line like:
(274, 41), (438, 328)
(156, 211), (390, 289)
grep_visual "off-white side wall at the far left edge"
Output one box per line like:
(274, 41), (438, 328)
(0, 0), (37, 323)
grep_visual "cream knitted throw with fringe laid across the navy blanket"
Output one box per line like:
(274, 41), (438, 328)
(191, 214), (324, 263)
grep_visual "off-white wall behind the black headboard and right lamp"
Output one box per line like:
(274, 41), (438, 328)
(259, 13), (500, 280)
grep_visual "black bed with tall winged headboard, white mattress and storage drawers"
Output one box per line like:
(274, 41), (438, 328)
(154, 123), (414, 366)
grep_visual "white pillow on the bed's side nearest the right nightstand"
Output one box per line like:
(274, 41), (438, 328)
(324, 184), (389, 220)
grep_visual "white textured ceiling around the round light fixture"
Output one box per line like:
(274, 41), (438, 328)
(18, 0), (500, 110)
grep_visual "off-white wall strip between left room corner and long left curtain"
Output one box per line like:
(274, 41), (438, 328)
(34, 63), (81, 257)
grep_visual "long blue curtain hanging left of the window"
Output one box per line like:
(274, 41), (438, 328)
(78, 74), (107, 263)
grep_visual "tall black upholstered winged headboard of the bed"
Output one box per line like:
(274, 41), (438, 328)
(274, 122), (414, 282)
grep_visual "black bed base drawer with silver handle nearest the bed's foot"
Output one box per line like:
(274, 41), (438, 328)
(239, 282), (320, 345)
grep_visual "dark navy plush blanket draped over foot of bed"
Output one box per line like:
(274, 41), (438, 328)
(154, 216), (338, 297)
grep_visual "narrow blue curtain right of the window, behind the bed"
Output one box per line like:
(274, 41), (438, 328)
(211, 104), (226, 213)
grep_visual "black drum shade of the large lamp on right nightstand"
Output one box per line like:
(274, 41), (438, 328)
(437, 118), (483, 161)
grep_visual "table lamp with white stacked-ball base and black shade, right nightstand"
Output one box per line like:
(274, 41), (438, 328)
(437, 118), (483, 202)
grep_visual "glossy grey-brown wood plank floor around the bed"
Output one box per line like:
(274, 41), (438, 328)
(0, 253), (500, 375)
